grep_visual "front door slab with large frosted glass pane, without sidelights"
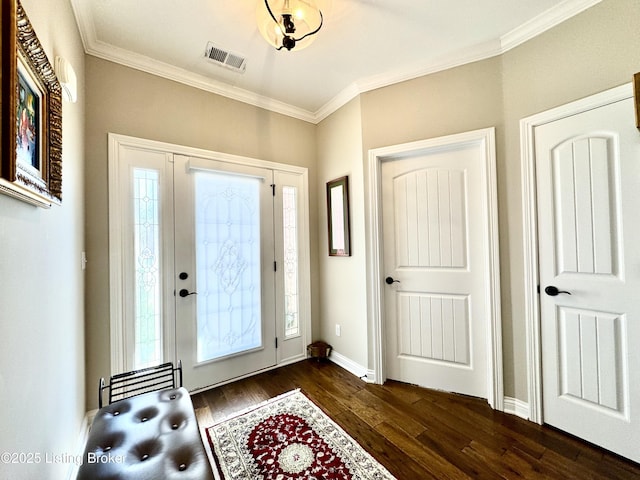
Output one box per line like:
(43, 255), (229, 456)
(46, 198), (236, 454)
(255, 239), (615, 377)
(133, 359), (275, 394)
(174, 155), (276, 390)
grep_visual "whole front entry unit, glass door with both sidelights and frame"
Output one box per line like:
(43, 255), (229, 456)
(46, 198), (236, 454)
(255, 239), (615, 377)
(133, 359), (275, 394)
(109, 134), (311, 390)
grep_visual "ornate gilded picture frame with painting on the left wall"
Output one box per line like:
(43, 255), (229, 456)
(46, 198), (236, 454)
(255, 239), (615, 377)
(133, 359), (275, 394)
(0, 0), (62, 207)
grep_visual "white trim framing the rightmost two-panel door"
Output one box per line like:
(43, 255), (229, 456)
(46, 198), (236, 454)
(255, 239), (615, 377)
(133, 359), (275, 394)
(520, 83), (633, 424)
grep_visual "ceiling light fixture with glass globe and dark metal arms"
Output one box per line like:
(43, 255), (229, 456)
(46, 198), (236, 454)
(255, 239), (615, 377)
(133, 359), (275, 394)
(257, 0), (323, 50)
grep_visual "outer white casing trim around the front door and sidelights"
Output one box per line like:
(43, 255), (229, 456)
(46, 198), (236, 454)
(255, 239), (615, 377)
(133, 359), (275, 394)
(108, 133), (312, 375)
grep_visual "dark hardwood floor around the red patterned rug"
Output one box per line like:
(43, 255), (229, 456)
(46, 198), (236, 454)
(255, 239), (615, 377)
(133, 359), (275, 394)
(193, 360), (640, 480)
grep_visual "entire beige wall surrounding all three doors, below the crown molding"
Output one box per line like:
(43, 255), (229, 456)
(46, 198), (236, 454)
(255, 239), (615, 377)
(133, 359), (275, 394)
(87, 0), (640, 405)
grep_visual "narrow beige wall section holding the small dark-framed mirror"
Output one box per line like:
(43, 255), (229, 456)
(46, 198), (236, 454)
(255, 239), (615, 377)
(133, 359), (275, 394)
(314, 98), (368, 368)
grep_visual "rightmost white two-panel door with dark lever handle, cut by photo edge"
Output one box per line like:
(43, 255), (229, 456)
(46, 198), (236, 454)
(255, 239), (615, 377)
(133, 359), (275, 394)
(534, 99), (640, 461)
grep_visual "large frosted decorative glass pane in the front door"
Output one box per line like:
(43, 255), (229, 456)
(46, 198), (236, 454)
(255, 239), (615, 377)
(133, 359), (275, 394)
(195, 172), (262, 362)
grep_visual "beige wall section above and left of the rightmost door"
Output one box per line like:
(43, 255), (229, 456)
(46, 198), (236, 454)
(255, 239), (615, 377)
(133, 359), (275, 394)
(498, 0), (640, 400)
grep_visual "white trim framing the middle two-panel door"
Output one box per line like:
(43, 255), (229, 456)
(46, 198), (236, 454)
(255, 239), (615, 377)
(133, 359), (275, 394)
(366, 127), (504, 411)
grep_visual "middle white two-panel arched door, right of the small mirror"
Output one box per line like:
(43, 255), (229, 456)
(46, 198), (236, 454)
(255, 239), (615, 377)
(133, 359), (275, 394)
(381, 131), (500, 398)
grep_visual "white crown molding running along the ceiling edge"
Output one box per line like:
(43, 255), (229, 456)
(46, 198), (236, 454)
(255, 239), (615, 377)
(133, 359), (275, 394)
(71, 0), (602, 124)
